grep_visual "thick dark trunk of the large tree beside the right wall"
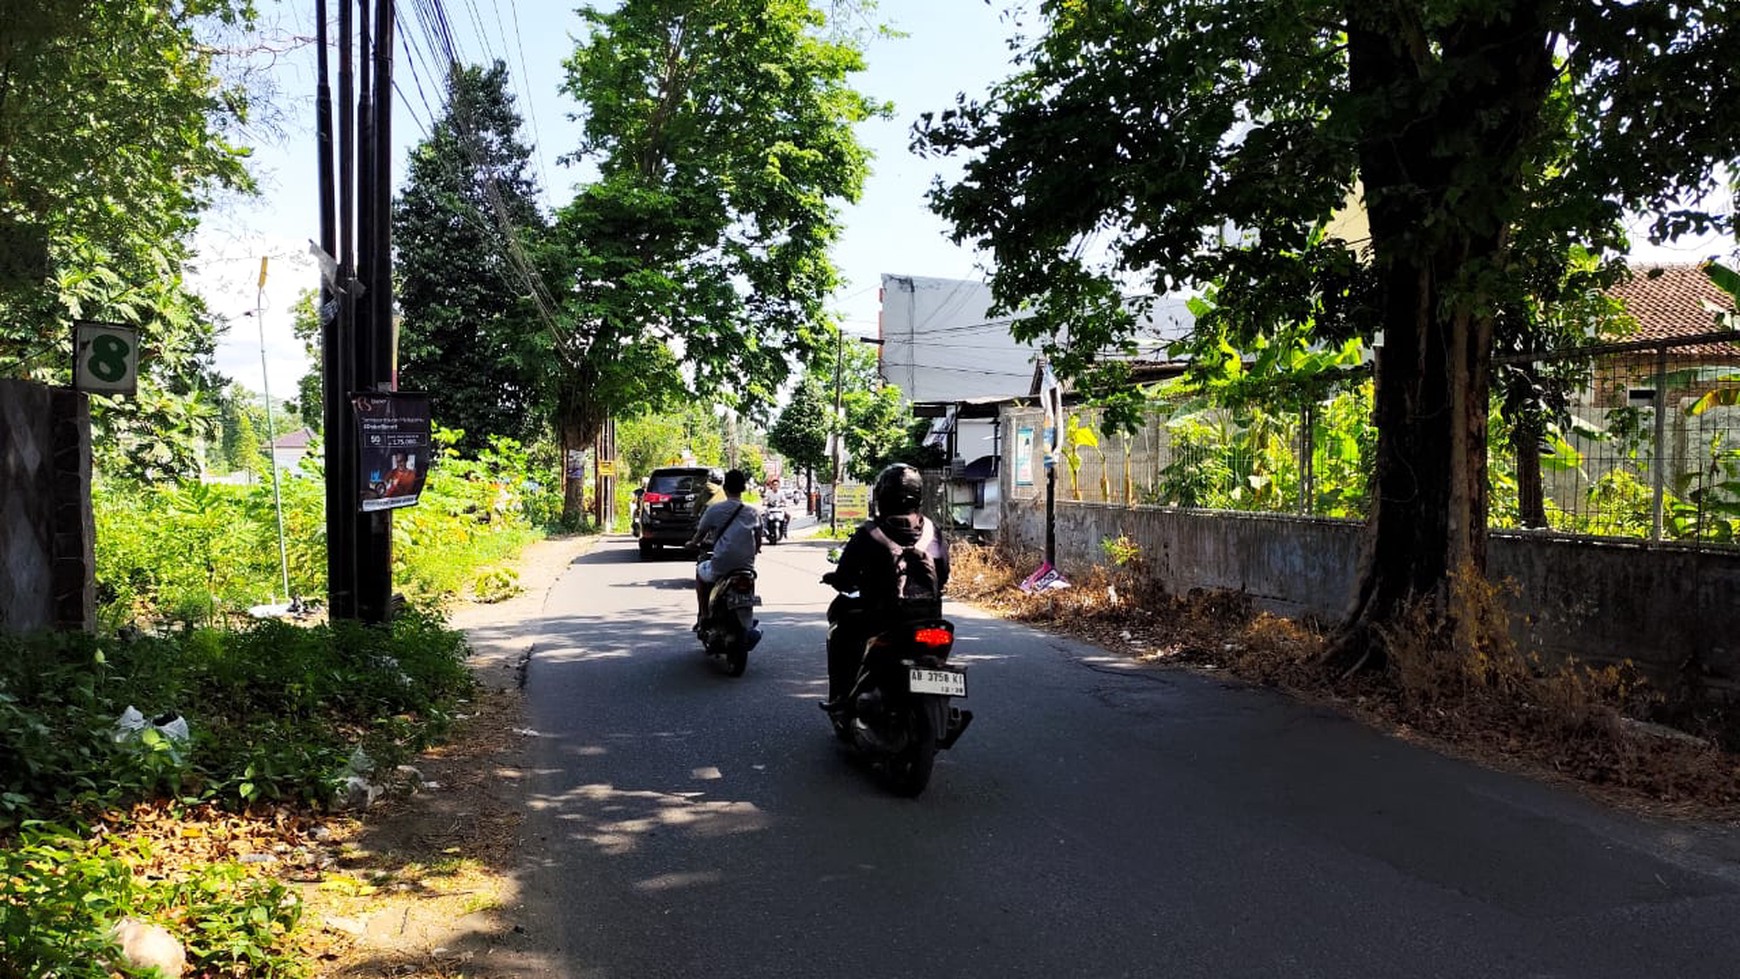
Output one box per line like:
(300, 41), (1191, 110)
(1331, 2), (1552, 669)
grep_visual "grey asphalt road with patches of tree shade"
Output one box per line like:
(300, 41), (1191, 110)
(525, 528), (1740, 979)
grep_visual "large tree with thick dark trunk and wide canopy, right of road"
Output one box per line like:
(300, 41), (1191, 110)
(915, 0), (1740, 659)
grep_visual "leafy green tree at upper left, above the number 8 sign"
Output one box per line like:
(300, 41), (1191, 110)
(0, 0), (249, 476)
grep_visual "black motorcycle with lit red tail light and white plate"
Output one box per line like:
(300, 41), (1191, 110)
(823, 580), (973, 796)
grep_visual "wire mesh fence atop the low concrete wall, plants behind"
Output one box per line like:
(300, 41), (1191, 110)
(1009, 334), (1740, 544)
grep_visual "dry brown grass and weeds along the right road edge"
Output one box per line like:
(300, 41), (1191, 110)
(950, 546), (1740, 821)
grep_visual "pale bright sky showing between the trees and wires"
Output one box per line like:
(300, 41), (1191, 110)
(193, 0), (1011, 398)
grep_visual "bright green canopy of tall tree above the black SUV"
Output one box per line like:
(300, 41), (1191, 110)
(552, 0), (882, 521)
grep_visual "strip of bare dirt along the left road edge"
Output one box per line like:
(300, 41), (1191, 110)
(283, 537), (597, 979)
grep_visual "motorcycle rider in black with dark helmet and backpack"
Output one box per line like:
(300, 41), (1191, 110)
(821, 463), (948, 711)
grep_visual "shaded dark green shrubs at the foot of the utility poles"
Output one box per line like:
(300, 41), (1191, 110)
(0, 607), (472, 829)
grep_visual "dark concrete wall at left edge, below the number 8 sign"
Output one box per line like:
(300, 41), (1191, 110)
(0, 379), (96, 631)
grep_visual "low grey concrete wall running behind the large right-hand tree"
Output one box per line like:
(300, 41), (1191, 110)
(1002, 496), (1740, 687)
